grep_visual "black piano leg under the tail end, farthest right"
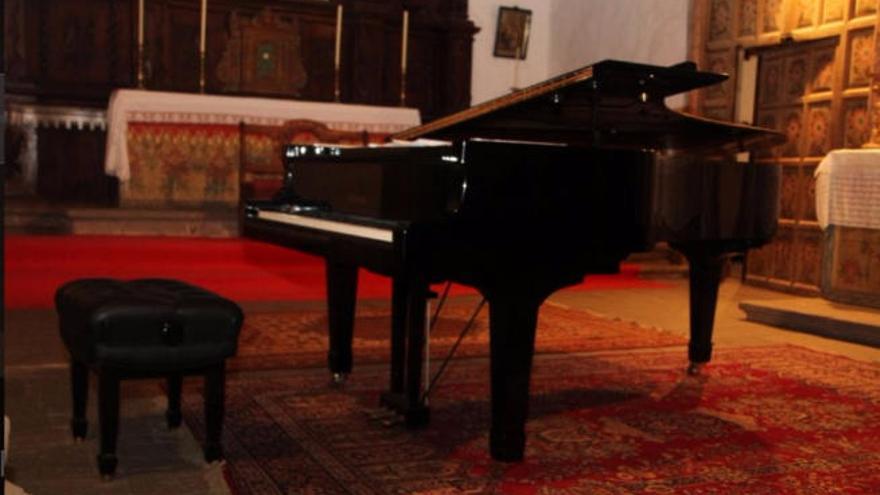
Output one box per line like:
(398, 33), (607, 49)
(677, 246), (725, 375)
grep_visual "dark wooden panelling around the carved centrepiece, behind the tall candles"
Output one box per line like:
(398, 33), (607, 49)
(5, 0), (476, 120)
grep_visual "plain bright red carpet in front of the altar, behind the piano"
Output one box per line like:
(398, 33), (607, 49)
(4, 236), (662, 308)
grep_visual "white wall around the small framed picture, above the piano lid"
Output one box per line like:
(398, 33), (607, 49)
(468, 0), (691, 107)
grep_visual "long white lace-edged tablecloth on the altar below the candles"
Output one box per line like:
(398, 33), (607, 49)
(104, 89), (420, 181)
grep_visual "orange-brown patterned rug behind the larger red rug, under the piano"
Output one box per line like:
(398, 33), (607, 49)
(229, 301), (687, 370)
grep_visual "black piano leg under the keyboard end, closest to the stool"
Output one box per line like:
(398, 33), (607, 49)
(327, 259), (358, 383)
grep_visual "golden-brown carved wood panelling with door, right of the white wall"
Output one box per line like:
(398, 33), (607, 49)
(691, 0), (880, 293)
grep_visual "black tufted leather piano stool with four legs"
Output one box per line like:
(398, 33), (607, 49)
(55, 278), (243, 476)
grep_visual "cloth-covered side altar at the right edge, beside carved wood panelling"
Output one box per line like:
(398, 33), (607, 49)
(815, 149), (880, 307)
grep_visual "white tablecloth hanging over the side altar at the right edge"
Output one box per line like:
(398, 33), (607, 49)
(815, 149), (880, 229)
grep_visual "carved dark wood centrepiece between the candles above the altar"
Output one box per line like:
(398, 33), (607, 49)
(217, 8), (308, 96)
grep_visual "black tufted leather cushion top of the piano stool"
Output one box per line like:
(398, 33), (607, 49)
(55, 278), (244, 372)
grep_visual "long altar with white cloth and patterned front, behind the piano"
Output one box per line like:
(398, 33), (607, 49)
(104, 89), (420, 207)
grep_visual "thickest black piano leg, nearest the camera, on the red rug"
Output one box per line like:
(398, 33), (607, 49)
(488, 294), (542, 461)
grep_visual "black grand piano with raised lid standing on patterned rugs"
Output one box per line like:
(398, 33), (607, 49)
(244, 60), (784, 461)
